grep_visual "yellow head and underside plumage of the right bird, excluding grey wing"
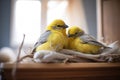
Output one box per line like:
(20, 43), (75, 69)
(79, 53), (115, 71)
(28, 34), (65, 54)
(68, 26), (101, 54)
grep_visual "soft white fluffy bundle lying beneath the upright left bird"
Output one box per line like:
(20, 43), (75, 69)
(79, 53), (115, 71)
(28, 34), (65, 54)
(33, 50), (73, 63)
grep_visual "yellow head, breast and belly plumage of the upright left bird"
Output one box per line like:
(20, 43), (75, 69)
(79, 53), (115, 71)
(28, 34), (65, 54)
(36, 20), (68, 51)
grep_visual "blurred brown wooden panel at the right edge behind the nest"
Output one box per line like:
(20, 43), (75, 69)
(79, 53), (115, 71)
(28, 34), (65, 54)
(102, 0), (120, 44)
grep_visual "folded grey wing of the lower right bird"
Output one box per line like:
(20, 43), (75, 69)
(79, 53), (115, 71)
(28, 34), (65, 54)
(80, 34), (105, 47)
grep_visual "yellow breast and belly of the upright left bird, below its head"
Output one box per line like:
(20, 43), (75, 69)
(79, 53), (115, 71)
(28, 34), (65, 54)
(36, 31), (66, 51)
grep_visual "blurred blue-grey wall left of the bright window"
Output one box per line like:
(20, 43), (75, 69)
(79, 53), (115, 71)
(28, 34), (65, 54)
(0, 0), (10, 48)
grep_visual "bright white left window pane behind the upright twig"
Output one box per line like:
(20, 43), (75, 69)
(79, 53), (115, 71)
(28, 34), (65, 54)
(11, 0), (41, 46)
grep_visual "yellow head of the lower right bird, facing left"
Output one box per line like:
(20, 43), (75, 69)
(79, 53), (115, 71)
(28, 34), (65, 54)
(68, 26), (84, 37)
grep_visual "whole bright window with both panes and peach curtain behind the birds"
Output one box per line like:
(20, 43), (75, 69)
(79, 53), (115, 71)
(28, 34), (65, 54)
(11, 0), (86, 47)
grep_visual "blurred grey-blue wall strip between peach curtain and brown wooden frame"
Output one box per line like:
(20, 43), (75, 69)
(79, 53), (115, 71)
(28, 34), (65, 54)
(83, 0), (97, 38)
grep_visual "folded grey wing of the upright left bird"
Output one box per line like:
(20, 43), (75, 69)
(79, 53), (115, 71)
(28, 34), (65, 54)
(34, 30), (51, 48)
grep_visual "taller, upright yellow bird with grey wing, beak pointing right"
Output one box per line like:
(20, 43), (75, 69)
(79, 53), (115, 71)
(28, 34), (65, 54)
(33, 19), (68, 52)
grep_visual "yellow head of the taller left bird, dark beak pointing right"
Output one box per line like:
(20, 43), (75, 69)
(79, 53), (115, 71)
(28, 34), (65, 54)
(47, 19), (68, 32)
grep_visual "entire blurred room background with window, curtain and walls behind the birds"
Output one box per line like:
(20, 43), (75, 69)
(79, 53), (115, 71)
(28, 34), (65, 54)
(0, 0), (120, 48)
